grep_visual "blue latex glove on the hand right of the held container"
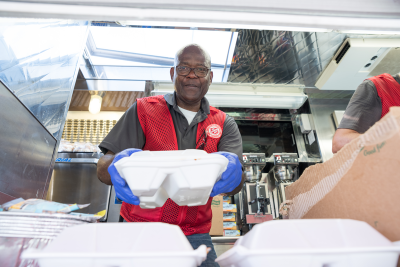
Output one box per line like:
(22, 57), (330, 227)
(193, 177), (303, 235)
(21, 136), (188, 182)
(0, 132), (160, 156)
(210, 152), (242, 197)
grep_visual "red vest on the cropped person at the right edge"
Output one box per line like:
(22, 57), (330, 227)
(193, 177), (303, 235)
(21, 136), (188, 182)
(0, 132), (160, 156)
(368, 73), (400, 118)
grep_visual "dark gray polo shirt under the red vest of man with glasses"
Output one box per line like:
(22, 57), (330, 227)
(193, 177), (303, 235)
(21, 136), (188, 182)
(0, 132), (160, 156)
(99, 93), (243, 166)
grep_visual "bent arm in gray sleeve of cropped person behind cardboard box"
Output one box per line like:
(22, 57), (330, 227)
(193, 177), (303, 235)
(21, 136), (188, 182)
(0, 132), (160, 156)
(332, 80), (382, 153)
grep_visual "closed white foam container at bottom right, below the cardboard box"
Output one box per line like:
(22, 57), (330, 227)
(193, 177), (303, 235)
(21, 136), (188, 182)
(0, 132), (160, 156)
(216, 219), (400, 267)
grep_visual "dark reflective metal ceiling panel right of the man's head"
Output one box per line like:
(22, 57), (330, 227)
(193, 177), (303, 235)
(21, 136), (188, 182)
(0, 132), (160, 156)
(228, 30), (400, 87)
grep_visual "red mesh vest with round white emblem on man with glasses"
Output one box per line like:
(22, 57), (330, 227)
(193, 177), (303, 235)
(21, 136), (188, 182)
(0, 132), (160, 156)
(121, 96), (226, 235)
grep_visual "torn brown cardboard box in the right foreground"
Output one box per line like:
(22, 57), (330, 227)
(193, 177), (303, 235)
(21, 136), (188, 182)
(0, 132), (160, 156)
(286, 107), (400, 241)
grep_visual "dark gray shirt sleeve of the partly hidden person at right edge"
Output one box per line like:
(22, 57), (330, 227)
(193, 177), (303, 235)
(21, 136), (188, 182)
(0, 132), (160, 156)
(338, 75), (400, 133)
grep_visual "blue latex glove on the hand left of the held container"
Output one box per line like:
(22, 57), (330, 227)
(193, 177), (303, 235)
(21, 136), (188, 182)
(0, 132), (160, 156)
(108, 148), (142, 205)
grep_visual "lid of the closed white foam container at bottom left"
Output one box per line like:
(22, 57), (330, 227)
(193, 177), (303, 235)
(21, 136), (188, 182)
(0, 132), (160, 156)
(22, 223), (207, 265)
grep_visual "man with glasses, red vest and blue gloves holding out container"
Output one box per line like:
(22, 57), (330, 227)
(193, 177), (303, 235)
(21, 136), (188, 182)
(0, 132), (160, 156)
(97, 44), (244, 266)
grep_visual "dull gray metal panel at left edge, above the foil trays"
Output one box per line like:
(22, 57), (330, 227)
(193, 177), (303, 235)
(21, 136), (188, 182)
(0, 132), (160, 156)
(0, 82), (56, 203)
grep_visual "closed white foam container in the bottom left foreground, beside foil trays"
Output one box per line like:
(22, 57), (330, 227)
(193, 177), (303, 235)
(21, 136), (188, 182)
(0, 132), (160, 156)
(21, 223), (207, 267)
